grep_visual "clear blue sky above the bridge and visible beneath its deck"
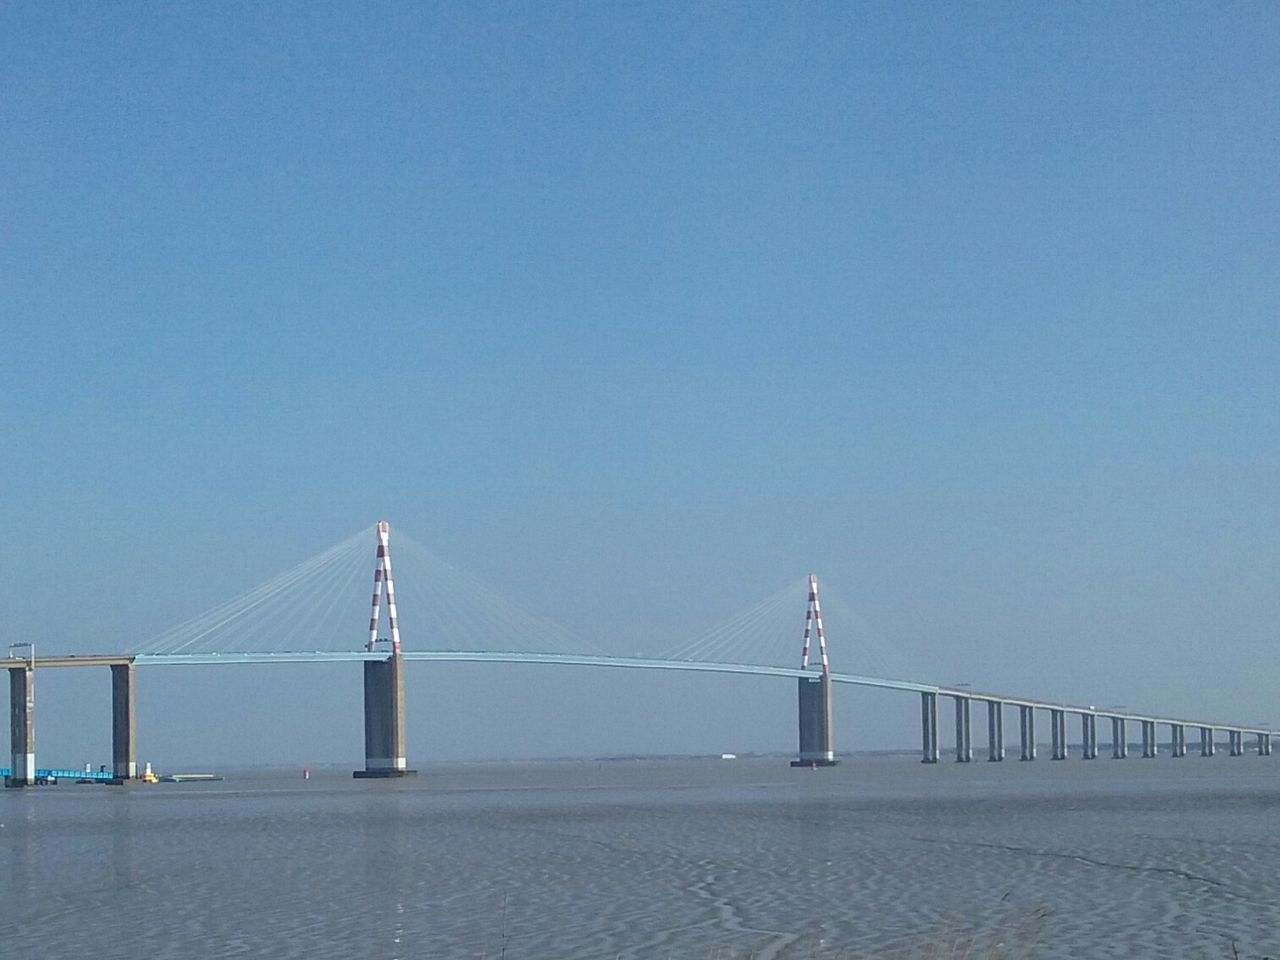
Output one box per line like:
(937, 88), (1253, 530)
(0, 3), (1280, 763)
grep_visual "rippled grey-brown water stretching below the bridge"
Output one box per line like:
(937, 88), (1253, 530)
(0, 755), (1280, 960)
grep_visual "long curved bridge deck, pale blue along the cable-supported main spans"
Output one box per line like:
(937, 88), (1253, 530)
(0, 650), (1276, 735)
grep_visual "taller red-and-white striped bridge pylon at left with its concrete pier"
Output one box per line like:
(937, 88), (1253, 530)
(352, 520), (417, 780)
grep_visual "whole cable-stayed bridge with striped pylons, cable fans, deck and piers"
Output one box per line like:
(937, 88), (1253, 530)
(4, 522), (1272, 786)
